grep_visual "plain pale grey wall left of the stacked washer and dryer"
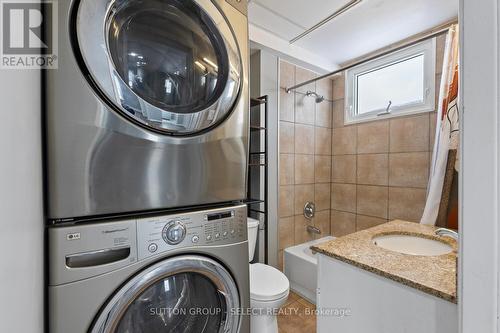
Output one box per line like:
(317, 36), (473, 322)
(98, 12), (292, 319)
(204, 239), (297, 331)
(0, 70), (45, 333)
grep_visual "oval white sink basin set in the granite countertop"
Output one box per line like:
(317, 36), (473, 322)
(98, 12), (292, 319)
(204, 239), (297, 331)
(373, 235), (453, 256)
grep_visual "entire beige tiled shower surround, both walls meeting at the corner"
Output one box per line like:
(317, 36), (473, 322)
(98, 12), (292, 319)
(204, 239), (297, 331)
(278, 36), (445, 263)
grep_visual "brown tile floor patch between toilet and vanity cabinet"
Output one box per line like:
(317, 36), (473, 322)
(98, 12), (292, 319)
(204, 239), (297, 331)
(278, 291), (316, 333)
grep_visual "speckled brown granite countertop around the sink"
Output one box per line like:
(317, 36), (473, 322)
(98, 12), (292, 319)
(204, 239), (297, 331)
(311, 220), (457, 303)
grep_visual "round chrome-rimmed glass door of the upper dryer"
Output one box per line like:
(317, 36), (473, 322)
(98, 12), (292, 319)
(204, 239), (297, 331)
(74, 0), (242, 135)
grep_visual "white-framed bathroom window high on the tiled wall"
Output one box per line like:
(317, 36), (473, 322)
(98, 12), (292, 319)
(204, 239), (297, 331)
(345, 38), (436, 124)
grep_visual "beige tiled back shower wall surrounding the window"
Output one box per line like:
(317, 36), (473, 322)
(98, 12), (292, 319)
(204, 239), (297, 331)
(331, 35), (445, 236)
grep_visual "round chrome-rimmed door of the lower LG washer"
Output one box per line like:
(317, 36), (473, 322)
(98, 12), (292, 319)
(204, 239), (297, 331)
(90, 256), (240, 333)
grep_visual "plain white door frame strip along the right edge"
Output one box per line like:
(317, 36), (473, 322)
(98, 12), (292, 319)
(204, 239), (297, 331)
(457, 0), (500, 333)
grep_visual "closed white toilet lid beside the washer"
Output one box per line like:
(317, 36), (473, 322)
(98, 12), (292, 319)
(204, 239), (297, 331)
(250, 263), (290, 301)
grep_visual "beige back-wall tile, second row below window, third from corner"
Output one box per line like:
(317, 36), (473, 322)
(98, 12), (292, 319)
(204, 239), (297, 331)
(389, 152), (429, 188)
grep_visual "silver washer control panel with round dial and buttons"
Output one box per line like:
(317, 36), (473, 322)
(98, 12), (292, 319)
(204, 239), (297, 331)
(137, 205), (247, 260)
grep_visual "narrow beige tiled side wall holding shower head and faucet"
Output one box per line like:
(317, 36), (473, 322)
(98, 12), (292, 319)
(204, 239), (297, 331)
(278, 61), (332, 267)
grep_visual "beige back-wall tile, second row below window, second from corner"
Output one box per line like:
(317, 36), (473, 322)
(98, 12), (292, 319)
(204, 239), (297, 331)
(357, 154), (389, 185)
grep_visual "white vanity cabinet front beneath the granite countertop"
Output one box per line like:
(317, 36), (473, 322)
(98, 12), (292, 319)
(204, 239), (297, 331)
(317, 254), (458, 333)
